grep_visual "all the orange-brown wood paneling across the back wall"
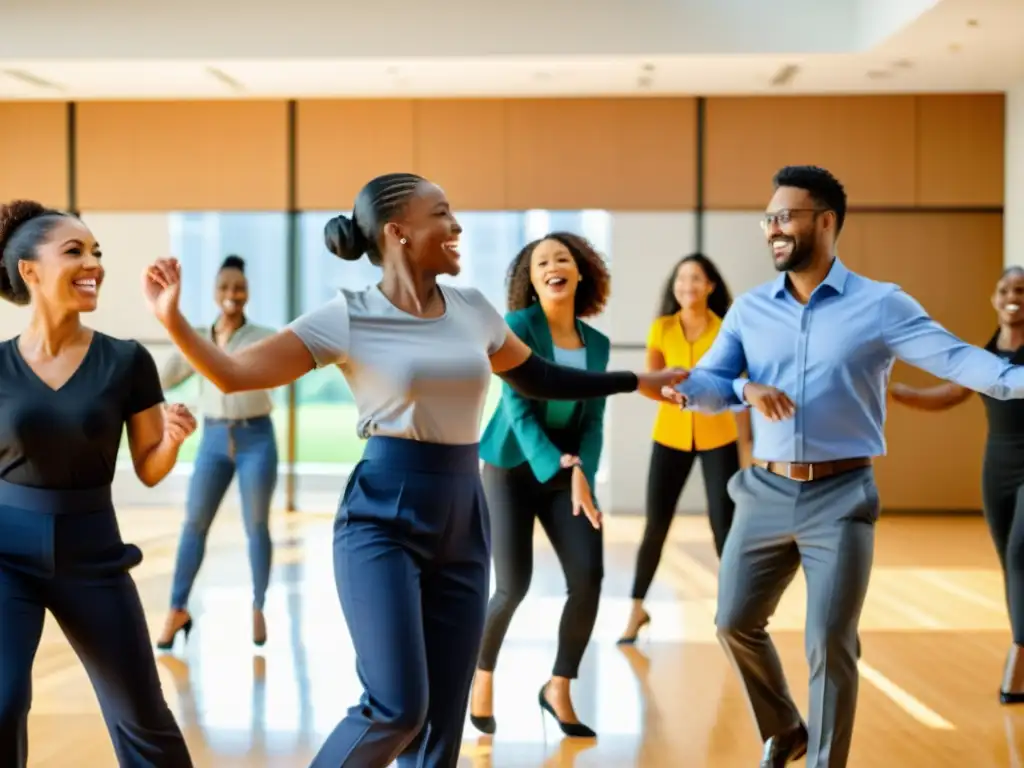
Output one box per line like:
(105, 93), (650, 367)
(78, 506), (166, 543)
(0, 94), (1005, 509)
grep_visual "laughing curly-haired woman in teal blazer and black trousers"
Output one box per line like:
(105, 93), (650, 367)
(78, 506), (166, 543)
(470, 232), (610, 737)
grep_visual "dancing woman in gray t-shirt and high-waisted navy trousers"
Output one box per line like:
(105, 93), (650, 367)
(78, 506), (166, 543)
(143, 173), (685, 768)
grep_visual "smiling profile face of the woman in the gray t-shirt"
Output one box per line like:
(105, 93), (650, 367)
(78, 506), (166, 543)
(384, 181), (462, 275)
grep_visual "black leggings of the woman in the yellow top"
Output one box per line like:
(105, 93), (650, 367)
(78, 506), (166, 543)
(633, 442), (739, 600)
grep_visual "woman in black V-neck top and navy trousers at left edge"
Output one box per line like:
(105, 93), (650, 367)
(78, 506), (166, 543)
(0, 201), (196, 768)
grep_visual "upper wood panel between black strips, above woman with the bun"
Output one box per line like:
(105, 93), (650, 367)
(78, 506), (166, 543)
(296, 98), (696, 211)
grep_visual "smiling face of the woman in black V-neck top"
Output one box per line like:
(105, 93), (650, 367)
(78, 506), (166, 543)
(17, 216), (103, 312)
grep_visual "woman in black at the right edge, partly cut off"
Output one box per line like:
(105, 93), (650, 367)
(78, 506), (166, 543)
(889, 266), (1024, 703)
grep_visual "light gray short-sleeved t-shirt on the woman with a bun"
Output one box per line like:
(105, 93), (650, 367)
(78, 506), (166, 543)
(289, 286), (508, 445)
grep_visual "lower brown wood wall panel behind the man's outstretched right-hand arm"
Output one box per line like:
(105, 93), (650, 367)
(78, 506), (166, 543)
(839, 212), (1002, 510)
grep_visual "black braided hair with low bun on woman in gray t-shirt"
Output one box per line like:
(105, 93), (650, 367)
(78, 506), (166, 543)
(324, 173), (426, 266)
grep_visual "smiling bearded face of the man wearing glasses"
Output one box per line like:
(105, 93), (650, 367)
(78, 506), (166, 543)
(762, 186), (836, 272)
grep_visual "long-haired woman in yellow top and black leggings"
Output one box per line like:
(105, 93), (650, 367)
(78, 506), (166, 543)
(620, 254), (751, 643)
